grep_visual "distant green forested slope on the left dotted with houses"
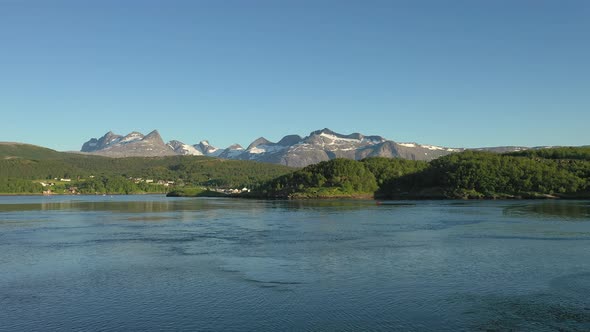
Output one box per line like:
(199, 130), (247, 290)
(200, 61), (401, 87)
(0, 144), (293, 193)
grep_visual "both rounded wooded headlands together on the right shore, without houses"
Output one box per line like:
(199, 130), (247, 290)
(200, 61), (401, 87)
(252, 148), (590, 199)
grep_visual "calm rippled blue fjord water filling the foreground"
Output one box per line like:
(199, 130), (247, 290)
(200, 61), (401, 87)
(0, 196), (590, 331)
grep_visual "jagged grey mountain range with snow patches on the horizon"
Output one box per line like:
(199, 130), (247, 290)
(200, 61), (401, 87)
(81, 128), (527, 167)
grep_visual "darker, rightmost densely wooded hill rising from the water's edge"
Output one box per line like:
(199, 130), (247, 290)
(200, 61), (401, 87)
(379, 151), (590, 198)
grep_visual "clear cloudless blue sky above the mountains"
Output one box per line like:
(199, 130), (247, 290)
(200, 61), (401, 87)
(0, 0), (590, 150)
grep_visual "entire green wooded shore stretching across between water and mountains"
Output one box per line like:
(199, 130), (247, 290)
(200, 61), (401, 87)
(0, 143), (590, 199)
